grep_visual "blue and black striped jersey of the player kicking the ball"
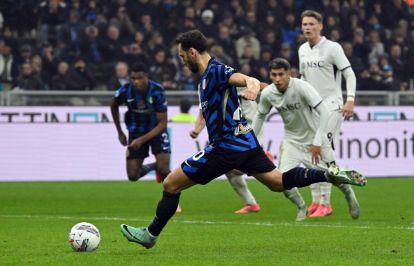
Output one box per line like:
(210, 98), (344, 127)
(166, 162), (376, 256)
(198, 58), (259, 151)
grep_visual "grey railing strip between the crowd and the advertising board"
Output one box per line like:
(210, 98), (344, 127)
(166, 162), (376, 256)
(0, 89), (414, 106)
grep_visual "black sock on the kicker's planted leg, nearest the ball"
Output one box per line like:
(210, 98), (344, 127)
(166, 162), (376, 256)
(148, 191), (180, 236)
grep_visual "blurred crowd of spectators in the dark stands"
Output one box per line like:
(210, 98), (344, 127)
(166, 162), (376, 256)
(0, 0), (414, 91)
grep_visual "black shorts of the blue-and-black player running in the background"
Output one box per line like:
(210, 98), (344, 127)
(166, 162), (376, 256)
(126, 131), (171, 160)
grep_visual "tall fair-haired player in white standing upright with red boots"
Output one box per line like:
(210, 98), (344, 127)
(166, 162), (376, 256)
(299, 10), (356, 217)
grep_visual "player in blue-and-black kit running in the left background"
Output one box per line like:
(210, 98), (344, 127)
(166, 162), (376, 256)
(111, 63), (171, 185)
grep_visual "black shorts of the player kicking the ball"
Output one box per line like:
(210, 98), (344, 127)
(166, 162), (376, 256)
(181, 145), (276, 185)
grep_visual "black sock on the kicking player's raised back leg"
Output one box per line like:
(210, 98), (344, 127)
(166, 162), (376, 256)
(282, 167), (327, 189)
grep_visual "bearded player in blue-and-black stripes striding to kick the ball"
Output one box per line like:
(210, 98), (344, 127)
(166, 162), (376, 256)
(121, 30), (366, 248)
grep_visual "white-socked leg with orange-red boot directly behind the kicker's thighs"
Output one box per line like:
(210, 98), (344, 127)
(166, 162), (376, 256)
(226, 170), (260, 214)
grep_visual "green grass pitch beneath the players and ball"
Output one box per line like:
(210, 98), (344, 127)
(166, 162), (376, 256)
(0, 179), (414, 265)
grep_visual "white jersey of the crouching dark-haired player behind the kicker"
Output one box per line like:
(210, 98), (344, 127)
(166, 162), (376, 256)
(257, 78), (326, 145)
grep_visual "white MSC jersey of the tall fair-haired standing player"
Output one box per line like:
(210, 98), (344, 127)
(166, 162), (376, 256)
(299, 37), (351, 110)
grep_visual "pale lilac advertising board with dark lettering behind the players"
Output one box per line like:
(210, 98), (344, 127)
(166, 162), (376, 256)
(0, 106), (414, 181)
